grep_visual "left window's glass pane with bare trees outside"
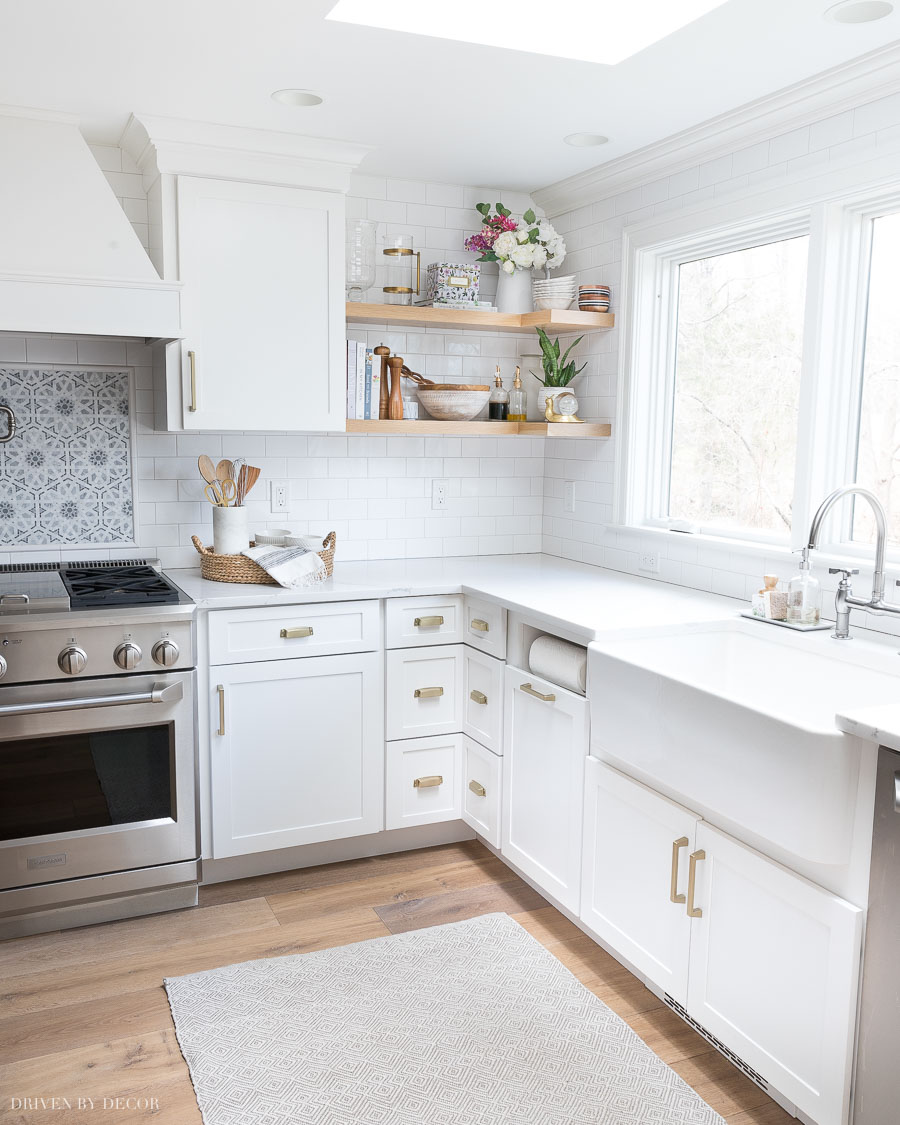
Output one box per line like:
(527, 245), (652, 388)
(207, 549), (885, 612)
(668, 236), (810, 536)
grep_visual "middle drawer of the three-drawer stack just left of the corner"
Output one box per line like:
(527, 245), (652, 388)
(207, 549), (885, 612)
(385, 645), (462, 740)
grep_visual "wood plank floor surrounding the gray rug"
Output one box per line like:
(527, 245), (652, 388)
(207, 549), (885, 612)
(0, 842), (793, 1125)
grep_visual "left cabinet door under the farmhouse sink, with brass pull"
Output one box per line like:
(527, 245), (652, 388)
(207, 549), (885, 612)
(579, 757), (700, 1005)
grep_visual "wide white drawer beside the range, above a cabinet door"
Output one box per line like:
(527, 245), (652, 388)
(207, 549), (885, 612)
(209, 602), (379, 664)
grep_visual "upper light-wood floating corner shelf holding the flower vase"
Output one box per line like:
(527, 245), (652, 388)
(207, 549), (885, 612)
(347, 302), (615, 330)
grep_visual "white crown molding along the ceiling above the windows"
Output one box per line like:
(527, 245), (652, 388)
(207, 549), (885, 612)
(532, 43), (900, 218)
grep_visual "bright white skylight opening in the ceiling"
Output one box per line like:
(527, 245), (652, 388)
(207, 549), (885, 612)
(326, 0), (725, 64)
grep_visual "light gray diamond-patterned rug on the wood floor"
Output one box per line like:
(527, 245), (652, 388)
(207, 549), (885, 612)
(165, 914), (725, 1125)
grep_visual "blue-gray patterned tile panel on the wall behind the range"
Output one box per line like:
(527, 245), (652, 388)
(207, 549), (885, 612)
(0, 366), (134, 547)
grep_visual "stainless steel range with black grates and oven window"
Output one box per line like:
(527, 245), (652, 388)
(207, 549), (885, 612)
(0, 560), (199, 938)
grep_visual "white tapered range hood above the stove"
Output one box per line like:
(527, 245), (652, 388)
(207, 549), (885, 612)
(0, 106), (181, 339)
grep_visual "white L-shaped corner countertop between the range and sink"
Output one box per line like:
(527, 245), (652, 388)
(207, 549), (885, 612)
(168, 555), (744, 640)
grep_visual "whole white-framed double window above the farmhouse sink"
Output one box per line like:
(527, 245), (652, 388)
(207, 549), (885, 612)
(617, 178), (900, 565)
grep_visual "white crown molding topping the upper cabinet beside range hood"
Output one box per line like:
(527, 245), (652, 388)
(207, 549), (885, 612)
(119, 114), (372, 191)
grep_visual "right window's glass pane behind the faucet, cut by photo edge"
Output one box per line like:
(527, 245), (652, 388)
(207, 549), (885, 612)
(853, 214), (900, 543)
